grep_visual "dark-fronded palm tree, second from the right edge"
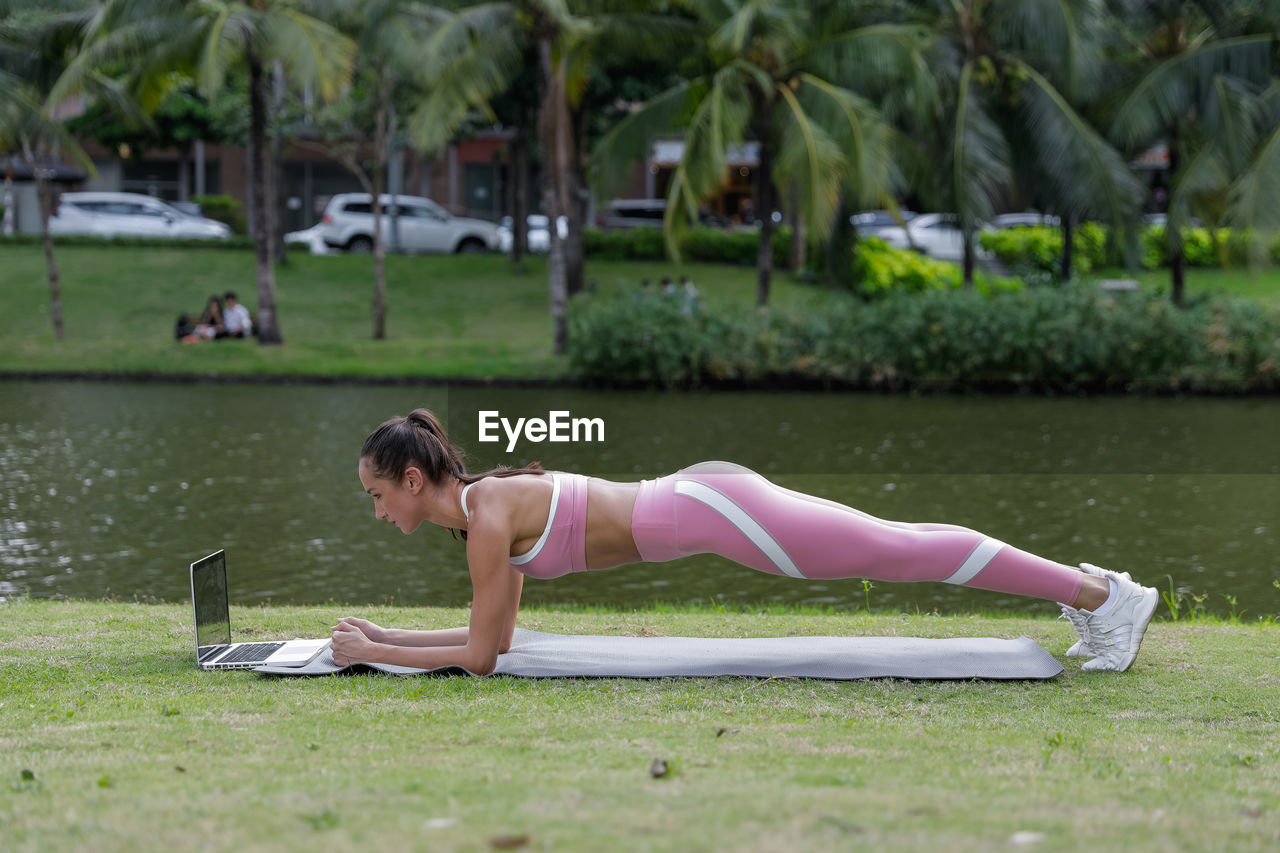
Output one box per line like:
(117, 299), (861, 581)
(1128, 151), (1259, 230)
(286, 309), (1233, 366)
(885, 0), (1142, 284)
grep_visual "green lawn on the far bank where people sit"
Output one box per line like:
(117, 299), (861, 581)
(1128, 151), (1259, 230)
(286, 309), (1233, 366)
(0, 246), (798, 378)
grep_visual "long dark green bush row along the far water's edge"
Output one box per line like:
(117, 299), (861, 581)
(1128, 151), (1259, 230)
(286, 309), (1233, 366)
(568, 287), (1280, 392)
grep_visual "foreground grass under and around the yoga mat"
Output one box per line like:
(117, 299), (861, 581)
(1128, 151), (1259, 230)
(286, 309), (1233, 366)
(0, 599), (1280, 850)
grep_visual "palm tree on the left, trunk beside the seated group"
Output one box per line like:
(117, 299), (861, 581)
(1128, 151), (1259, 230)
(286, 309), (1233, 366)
(55, 0), (355, 345)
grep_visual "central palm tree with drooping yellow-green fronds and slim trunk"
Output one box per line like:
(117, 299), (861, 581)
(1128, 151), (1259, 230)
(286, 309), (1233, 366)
(595, 0), (918, 305)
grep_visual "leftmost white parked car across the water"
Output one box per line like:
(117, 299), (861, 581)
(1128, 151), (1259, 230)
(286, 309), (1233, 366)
(49, 192), (232, 240)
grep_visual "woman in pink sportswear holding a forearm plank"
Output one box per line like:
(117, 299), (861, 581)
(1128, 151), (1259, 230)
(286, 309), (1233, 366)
(333, 409), (1158, 675)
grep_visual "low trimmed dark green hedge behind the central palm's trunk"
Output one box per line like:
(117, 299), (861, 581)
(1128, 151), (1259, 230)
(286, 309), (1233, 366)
(584, 225), (791, 269)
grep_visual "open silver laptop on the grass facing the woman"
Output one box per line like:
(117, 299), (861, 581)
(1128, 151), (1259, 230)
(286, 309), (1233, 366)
(191, 551), (329, 670)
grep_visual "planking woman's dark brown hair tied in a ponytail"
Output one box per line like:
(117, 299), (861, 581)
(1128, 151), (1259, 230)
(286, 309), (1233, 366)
(360, 409), (543, 485)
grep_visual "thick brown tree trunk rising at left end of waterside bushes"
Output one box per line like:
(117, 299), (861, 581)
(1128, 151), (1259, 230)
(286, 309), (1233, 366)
(538, 33), (568, 355)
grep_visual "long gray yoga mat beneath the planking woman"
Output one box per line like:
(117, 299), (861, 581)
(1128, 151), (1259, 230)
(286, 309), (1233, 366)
(256, 628), (1062, 680)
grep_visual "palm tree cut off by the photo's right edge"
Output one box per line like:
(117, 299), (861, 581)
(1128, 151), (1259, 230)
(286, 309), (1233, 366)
(1111, 0), (1280, 305)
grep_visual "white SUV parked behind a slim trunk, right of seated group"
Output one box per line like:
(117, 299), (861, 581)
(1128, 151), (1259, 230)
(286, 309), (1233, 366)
(319, 192), (498, 252)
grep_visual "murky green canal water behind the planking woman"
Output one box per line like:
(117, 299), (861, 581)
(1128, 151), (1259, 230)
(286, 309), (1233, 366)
(0, 382), (1280, 617)
